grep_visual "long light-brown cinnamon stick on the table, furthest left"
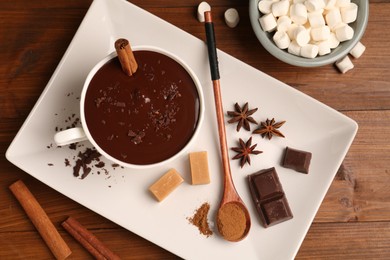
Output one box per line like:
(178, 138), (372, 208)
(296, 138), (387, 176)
(9, 180), (72, 259)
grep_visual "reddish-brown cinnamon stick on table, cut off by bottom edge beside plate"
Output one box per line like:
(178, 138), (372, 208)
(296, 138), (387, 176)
(62, 217), (120, 260)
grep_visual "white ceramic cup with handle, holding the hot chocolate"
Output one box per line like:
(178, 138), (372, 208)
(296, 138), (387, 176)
(54, 46), (204, 169)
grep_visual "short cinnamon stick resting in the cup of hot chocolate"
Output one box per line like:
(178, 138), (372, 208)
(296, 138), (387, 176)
(115, 38), (138, 76)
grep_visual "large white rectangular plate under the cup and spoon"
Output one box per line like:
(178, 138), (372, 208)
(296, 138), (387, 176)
(6, 0), (357, 259)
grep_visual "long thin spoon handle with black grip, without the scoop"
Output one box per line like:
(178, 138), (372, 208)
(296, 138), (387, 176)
(205, 11), (239, 204)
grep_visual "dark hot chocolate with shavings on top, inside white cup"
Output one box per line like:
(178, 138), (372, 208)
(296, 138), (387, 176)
(84, 50), (200, 165)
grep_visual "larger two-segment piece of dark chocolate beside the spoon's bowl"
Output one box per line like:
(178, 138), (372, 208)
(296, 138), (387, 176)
(248, 167), (293, 227)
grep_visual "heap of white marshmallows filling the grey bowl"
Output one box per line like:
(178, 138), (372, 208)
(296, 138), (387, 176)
(258, 0), (358, 58)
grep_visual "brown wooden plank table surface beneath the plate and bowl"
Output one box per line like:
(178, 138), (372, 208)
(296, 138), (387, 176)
(0, 0), (390, 259)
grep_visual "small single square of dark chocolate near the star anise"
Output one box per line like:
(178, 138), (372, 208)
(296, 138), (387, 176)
(282, 147), (311, 174)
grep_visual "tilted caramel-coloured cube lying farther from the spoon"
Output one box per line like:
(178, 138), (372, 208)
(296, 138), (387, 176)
(149, 169), (183, 201)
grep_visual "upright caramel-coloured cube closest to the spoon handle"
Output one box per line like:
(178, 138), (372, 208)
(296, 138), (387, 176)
(189, 152), (210, 185)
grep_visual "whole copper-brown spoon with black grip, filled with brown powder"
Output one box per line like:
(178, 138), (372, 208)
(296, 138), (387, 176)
(205, 11), (251, 242)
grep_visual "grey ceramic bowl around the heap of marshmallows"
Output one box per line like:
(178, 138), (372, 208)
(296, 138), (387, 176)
(249, 0), (369, 67)
